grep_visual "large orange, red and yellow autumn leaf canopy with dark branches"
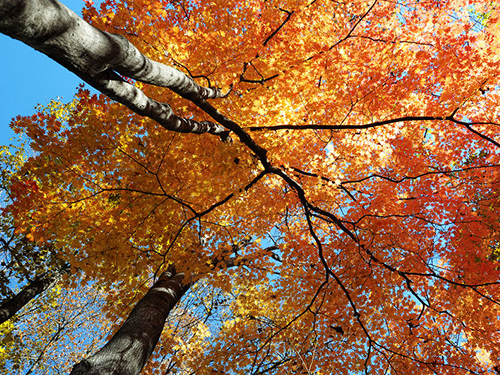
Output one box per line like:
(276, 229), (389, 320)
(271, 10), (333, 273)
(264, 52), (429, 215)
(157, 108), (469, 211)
(4, 0), (500, 375)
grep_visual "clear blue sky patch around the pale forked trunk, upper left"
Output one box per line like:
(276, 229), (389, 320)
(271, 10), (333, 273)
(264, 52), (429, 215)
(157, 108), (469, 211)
(0, 0), (99, 145)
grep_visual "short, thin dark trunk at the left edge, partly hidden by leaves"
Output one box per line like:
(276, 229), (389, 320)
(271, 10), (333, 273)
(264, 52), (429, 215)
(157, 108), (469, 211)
(0, 266), (70, 324)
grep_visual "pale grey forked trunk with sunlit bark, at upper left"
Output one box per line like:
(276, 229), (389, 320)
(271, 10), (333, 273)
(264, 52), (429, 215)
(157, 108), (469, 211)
(0, 0), (228, 138)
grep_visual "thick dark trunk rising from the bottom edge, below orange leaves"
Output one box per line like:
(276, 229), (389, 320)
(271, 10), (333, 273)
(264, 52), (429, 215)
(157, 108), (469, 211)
(71, 266), (191, 375)
